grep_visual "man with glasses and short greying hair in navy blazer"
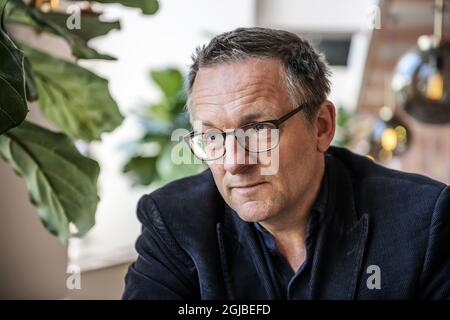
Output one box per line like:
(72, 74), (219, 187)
(124, 28), (450, 299)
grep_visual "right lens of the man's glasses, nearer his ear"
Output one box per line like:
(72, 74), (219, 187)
(237, 122), (279, 152)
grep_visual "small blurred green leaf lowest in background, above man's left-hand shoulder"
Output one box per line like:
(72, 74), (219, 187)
(122, 156), (158, 186)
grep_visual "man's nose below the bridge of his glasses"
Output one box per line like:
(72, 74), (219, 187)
(223, 135), (256, 175)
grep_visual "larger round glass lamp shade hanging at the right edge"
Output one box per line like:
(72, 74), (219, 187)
(392, 36), (450, 124)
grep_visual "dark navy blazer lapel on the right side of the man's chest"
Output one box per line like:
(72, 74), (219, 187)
(311, 158), (369, 299)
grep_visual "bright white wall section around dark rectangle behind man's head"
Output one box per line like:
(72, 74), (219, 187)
(257, 0), (378, 110)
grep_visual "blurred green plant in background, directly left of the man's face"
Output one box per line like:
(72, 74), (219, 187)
(123, 68), (200, 185)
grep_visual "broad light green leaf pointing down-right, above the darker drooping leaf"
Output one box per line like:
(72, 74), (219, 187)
(21, 44), (123, 141)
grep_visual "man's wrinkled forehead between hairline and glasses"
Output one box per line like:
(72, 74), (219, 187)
(191, 58), (289, 125)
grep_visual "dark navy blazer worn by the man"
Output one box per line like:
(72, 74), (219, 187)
(123, 147), (450, 299)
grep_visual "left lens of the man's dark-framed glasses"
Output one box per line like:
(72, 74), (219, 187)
(190, 130), (224, 160)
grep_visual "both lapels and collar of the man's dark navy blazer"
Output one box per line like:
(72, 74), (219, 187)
(216, 154), (369, 299)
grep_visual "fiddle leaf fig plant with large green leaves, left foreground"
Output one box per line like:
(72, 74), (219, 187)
(0, 0), (158, 243)
